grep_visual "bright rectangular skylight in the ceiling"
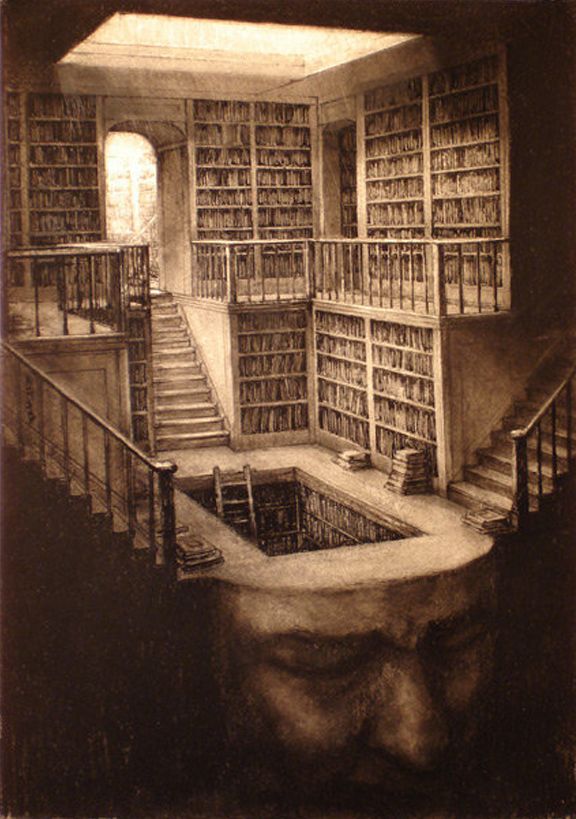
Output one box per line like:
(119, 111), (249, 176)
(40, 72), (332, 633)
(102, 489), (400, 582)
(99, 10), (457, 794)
(61, 13), (418, 79)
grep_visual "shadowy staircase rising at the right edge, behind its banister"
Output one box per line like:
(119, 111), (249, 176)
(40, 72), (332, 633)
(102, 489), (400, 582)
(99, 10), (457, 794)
(448, 359), (576, 515)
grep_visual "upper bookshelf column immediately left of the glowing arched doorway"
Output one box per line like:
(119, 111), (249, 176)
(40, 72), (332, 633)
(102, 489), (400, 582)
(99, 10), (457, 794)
(26, 93), (102, 245)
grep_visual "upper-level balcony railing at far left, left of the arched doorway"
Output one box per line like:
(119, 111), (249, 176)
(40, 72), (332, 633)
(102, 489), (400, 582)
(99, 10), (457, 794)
(5, 242), (150, 337)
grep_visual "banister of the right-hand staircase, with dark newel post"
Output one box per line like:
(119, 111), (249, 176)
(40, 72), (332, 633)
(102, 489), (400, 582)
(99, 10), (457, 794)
(510, 367), (576, 530)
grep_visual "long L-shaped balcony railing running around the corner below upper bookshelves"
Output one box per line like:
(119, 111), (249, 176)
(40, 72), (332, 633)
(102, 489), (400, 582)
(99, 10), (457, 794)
(191, 239), (510, 317)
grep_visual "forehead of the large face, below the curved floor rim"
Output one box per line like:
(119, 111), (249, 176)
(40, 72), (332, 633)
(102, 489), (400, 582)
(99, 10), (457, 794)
(220, 561), (494, 638)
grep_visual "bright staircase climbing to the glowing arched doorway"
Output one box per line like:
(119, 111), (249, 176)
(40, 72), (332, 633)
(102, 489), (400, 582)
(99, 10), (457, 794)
(152, 293), (230, 450)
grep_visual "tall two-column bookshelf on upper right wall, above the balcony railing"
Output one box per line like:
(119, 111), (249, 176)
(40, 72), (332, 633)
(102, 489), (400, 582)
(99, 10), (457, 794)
(364, 54), (507, 240)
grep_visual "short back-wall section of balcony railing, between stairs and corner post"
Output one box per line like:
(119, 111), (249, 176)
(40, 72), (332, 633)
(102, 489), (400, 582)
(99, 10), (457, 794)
(192, 239), (310, 304)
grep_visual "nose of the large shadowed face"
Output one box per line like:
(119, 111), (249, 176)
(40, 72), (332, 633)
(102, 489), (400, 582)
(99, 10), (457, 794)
(367, 657), (448, 771)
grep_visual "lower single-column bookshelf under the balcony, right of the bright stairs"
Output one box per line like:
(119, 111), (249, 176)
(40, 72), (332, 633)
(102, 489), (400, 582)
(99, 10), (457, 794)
(237, 309), (309, 439)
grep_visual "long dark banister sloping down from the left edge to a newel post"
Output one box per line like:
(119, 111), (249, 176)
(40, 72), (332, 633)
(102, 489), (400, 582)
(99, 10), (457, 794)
(2, 343), (176, 569)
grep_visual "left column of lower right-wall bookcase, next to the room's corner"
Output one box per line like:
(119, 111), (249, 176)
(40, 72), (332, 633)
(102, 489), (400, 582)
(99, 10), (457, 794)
(315, 310), (370, 449)
